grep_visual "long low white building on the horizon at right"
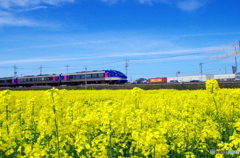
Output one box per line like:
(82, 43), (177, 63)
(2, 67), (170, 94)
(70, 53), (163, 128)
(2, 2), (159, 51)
(167, 74), (235, 82)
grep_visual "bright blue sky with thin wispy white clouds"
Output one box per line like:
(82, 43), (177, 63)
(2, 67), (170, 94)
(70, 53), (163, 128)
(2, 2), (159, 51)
(0, 0), (240, 80)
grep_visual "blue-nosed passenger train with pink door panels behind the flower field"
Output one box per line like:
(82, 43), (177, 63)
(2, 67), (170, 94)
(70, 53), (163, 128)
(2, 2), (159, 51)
(0, 70), (127, 87)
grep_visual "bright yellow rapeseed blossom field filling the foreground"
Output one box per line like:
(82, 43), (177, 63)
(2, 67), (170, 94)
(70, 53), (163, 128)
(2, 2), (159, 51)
(0, 80), (240, 158)
